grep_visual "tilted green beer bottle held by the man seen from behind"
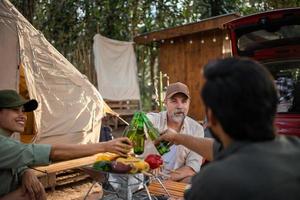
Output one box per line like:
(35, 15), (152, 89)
(141, 113), (170, 155)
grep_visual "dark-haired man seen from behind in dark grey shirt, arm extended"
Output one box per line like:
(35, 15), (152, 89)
(159, 58), (300, 200)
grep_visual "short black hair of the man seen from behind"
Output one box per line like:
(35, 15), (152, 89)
(202, 58), (277, 141)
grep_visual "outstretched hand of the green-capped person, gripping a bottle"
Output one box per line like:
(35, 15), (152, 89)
(105, 137), (132, 157)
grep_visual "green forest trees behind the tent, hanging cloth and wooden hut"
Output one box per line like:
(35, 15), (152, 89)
(11, 0), (300, 110)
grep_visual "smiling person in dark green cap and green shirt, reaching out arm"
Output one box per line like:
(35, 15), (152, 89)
(0, 90), (131, 200)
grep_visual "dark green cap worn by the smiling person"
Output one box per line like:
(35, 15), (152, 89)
(0, 90), (38, 112)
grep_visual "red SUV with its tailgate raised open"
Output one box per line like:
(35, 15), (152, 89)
(225, 8), (300, 136)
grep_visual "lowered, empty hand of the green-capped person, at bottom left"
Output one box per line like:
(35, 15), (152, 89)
(22, 169), (46, 200)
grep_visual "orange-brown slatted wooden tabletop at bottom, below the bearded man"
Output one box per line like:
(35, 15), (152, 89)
(148, 180), (189, 198)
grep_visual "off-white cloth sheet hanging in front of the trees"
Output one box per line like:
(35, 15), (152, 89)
(93, 34), (140, 101)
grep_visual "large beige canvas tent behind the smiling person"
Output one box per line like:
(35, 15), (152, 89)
(0, 0), (113, 144)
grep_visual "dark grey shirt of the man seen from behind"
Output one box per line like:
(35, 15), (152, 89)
(185, 136), (300, 200)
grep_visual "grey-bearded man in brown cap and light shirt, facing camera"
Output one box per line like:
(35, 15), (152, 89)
(144, 82), (204, 182)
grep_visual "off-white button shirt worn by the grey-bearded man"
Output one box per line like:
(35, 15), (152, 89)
(143, 111), (204, 172)
